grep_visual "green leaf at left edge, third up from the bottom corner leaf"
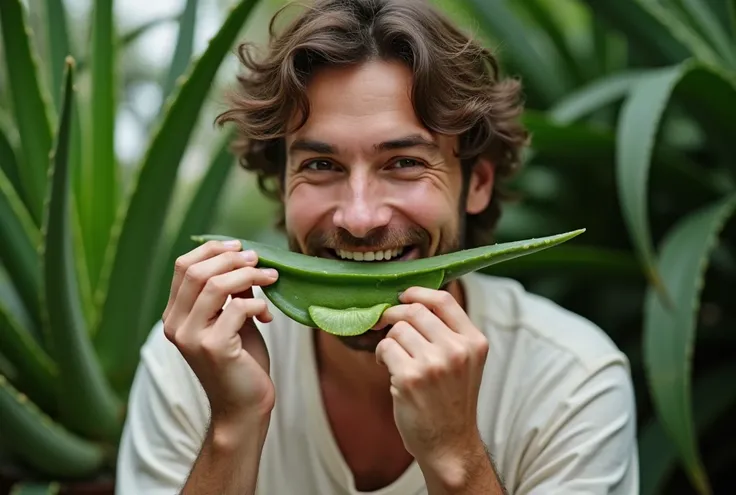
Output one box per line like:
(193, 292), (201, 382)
(0, 165), (41, 324)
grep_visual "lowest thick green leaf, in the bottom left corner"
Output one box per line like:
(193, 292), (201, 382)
(0, 375), (105, 477)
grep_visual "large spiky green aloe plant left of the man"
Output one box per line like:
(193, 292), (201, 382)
(0, 0), (264, 493)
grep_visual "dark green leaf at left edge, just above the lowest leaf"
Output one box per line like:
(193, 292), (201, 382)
(0, 301), (56, 411)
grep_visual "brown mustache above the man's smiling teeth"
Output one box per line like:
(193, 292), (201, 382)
(306, 227), (430, 253)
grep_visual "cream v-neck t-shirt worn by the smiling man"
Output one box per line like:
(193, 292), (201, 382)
(116, 273), (639, 495)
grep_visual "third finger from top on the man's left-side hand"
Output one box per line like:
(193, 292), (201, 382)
(188, 266), (278, 328)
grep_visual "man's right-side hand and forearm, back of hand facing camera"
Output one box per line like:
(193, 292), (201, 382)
(375, 287), (503, 494)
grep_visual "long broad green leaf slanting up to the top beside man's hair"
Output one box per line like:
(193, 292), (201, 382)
(96, 0), (257, 396)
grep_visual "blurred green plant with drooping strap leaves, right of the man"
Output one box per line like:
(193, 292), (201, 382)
(452, 0), (736, 495)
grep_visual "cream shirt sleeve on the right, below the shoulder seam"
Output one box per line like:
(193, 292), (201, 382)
(514, 356), (639, 495)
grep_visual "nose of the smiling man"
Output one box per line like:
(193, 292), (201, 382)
(333, 174), (391, 237)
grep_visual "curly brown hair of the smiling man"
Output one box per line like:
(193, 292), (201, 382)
(216, 0), (528, 247)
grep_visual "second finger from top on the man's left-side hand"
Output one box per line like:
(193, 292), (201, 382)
(169, 251), (258, 325)
